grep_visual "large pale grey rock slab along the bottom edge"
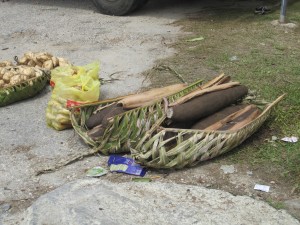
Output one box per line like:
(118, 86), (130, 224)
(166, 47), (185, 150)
(15, 178), (300, 225)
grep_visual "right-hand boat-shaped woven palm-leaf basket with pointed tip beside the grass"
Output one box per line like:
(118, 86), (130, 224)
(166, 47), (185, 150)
(131, 93), (284, 169)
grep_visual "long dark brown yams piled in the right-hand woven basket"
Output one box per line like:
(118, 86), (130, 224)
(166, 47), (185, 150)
(165, 74), (261, 131)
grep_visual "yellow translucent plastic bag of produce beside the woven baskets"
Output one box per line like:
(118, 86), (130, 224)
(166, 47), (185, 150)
(46, 63), (100, 130)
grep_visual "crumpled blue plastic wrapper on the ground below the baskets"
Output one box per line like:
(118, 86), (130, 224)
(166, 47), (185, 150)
(108, 155), (146, 177)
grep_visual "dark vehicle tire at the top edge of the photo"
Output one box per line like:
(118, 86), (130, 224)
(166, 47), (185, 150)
(92, 0), (139, 16)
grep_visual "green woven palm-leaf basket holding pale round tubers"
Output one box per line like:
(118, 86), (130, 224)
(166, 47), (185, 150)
(0, 66), (50, 107)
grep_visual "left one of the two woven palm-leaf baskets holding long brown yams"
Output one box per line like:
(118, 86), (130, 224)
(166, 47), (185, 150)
(71, 80), (202, 155)
